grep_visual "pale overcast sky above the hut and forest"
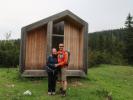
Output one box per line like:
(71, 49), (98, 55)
(0, 0), (133, 40)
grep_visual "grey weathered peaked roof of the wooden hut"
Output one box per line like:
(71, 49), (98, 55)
(22, 10), (87, 31)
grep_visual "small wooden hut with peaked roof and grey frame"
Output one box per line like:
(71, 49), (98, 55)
(20, 10), (88, 77)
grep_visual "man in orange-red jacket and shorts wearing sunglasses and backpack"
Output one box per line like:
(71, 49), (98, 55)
(55, 43), (68, 96)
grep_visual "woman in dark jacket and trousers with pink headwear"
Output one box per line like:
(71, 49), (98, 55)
(46, 48), (58, 95)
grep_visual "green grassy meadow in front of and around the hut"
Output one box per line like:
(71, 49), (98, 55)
(0, 65), (133, 100)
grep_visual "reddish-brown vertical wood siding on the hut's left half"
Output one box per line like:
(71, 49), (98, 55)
(25, 27), (47, 70)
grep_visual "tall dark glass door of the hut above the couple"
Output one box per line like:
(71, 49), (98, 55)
(52, 21), (64, 50)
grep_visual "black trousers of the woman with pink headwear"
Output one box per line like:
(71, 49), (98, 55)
(48, 72), (57, 92)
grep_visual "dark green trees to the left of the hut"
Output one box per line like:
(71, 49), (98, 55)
(0, 40), (20, 67)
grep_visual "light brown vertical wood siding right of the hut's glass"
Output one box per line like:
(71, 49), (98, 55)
(64, 21), (83, 70)
